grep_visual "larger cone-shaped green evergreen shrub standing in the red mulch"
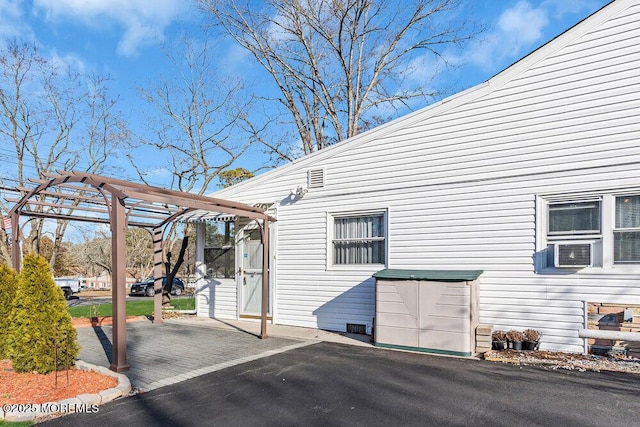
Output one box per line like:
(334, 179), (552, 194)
(8, 254), (80, 374)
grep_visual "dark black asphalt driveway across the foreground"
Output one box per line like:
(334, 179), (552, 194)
(44, 343), (640, 426)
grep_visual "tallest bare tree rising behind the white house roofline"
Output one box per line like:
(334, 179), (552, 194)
(196, 0), (481, 158)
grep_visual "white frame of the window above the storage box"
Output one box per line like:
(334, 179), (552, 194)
(326, 208), (389, 272)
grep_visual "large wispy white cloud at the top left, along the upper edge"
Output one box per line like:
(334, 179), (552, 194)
(32, 0), (189, 56)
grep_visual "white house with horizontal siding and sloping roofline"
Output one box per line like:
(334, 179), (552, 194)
(192, 0), (640, 352)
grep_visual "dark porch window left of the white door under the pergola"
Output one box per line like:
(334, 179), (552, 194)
(204, 222), (236, 279)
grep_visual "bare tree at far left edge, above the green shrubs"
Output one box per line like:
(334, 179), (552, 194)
(0, 40), (127, 266)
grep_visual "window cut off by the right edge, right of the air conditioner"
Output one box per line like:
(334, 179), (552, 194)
(613, 195), (640, 264)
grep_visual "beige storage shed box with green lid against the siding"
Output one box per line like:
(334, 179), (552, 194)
(373, 268), (482, 356)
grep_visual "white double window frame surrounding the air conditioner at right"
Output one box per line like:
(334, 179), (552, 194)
(535, 188), (640, 274)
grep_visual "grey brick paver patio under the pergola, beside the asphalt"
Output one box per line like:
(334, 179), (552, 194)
(78, 321), (313, 391)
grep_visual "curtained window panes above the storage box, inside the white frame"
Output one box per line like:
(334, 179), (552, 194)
(332, 213), (386, 265)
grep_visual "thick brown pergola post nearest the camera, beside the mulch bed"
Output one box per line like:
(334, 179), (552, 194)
(109, 194), (129, 372)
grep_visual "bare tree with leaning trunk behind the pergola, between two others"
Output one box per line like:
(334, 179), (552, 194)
(130, 37), (259, 295)
